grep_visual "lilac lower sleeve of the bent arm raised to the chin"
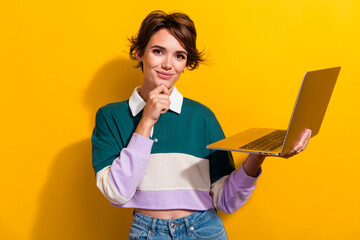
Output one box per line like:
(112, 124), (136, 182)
(109, 133), (153, 199)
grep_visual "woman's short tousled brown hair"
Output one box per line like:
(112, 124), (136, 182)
(129, 10), (205, 70)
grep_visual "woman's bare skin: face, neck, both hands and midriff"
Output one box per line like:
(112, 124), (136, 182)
(135, 29), (311, 219)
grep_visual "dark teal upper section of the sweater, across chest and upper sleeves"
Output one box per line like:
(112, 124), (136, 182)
(92, 98), (234, 183)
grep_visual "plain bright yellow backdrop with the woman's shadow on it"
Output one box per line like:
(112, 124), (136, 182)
(0, 0), (360, 240)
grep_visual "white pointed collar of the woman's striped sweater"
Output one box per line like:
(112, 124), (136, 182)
(129, 86), (184, 117)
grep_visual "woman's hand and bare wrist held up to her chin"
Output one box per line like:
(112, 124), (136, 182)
(135, 85), (170, 137)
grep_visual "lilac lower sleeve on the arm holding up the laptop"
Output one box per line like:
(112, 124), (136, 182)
(220, 165), (262, 213)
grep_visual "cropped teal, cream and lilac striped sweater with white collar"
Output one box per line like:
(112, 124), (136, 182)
(91, 88), (261, 213)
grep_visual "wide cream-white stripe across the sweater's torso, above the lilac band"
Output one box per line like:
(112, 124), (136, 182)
(137, 153), (211, 191)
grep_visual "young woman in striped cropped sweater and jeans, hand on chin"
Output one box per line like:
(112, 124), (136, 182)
(92, 11), (311, 239)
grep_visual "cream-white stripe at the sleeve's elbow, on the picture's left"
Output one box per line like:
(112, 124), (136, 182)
(96, 166), (135, 205)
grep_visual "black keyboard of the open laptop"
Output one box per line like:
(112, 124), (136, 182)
(239, 130), (286, 151)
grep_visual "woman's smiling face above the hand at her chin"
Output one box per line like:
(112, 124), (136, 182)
(136, 29), (187, 91)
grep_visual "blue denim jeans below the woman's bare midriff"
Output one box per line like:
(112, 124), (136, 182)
(129, 209), (228, 240)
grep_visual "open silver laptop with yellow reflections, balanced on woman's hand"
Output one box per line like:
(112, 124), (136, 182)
(207, 67), (341, 156)
